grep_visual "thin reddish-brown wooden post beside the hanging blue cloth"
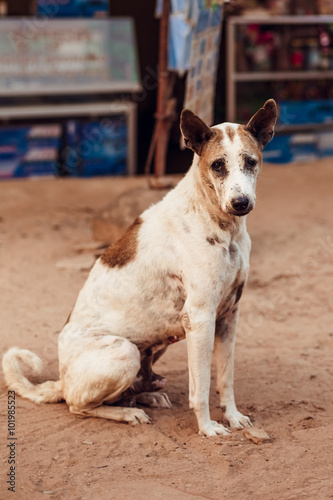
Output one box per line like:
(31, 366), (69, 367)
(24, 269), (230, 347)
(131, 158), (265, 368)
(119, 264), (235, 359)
(154, 0), (171, 177)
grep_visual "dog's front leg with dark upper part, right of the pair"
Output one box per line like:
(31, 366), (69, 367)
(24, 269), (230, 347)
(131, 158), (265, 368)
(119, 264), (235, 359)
(214, 308), (252, 429)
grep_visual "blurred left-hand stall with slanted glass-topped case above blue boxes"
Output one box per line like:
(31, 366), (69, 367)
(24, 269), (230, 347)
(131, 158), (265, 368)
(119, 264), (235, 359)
(0, 0), (141, 179)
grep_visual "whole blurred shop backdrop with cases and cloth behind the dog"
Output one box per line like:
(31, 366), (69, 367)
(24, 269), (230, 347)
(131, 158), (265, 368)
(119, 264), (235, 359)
(0, 0), (333, 179)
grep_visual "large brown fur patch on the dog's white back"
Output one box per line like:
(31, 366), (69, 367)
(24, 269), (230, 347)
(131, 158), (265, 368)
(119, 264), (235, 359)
(101, 217), (143, 267)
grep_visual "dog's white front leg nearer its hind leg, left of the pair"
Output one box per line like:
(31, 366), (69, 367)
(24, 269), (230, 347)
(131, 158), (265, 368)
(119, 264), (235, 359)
(184, 311), (229, 436)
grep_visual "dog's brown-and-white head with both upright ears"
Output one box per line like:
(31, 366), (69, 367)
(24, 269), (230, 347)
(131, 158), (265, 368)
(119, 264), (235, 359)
(180, 99), (277, 216)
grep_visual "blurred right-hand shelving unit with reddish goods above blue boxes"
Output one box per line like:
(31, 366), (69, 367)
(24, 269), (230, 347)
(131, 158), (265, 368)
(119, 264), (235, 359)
(225, 0), (333, 163)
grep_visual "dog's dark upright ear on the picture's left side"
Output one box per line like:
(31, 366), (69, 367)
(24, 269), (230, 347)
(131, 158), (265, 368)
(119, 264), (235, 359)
(180, 109), (214, 156)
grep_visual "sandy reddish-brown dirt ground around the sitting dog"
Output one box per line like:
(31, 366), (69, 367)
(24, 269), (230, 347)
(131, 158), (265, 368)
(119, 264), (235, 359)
(0, 159), (333, 500)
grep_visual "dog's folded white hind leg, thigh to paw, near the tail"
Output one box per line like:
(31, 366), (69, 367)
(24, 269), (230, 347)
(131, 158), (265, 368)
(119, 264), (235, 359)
(59, 335), (150, 425)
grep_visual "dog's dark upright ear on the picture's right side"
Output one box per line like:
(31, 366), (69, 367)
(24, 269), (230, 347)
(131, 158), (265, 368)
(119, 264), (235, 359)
(245, 99), (277, 147)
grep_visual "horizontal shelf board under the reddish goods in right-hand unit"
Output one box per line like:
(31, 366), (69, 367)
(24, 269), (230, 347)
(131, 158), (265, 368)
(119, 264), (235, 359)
(233, 71), (333, 82)
